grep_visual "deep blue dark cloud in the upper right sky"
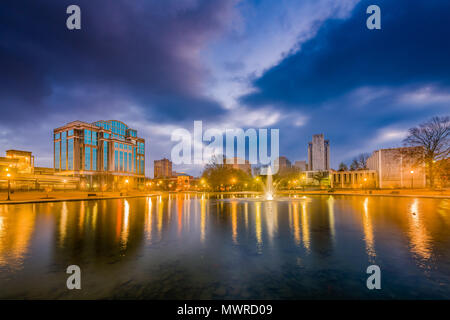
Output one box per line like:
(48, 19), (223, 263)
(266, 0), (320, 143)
(242, 0), (450, 108)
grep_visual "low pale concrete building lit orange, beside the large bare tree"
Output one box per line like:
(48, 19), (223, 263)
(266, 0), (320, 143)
(367, 148), (426, 188)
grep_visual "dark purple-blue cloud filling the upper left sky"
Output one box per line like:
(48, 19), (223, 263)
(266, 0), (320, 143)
(0, 0), (233, 121)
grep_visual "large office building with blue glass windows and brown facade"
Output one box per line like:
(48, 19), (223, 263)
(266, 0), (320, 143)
(53, 120), (145, 188)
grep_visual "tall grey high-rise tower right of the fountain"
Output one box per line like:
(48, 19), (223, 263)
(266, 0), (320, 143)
(308, 133), (330, 171)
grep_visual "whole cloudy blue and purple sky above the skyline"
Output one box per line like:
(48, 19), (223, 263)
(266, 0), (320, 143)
(0, 0), (450, 176)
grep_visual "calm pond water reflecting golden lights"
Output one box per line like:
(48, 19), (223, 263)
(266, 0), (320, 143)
(0, 194), (450, 299)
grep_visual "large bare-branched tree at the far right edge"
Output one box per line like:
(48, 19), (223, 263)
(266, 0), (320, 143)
(403, 116), (450, 188)
